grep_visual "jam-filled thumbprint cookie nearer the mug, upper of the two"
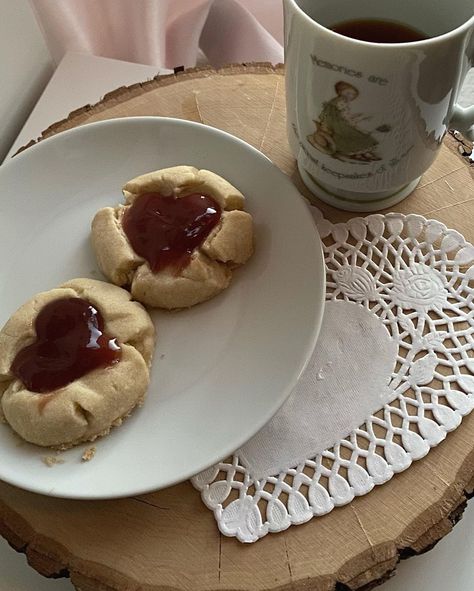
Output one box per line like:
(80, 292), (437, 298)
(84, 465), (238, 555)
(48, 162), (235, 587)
(92, 166), (253, 309)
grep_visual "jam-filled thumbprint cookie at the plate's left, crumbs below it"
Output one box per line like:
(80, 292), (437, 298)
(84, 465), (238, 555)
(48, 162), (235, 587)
(0, 279), (155, 449)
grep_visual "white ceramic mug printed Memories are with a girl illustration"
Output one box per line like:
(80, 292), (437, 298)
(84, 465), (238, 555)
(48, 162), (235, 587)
(283, 0), (474, 211)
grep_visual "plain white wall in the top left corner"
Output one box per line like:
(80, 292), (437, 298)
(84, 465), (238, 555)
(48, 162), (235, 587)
(0, 0), (54, 162)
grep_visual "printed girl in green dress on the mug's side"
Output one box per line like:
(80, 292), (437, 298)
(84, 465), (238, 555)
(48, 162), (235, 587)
(308, 80), (390, 164)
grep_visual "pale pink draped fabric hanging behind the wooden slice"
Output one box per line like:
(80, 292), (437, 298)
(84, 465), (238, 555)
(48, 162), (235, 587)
(31, 0), (283, 68)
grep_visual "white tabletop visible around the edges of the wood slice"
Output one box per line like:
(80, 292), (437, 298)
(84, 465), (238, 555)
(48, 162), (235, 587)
(0, 53), (474, 591)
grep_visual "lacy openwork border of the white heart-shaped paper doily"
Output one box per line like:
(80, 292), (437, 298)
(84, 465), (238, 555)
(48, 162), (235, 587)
(192, 208), (474, 542)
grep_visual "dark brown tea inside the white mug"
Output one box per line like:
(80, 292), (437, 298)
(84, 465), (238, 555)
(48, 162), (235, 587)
(329, 18), (428, 43)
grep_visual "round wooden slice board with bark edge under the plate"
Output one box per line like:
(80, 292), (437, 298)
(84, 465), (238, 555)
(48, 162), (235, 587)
(0, 64), (474, 591)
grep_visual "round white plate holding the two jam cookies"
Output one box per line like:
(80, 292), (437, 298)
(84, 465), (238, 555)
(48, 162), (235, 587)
(0, 117), (324, 499)
